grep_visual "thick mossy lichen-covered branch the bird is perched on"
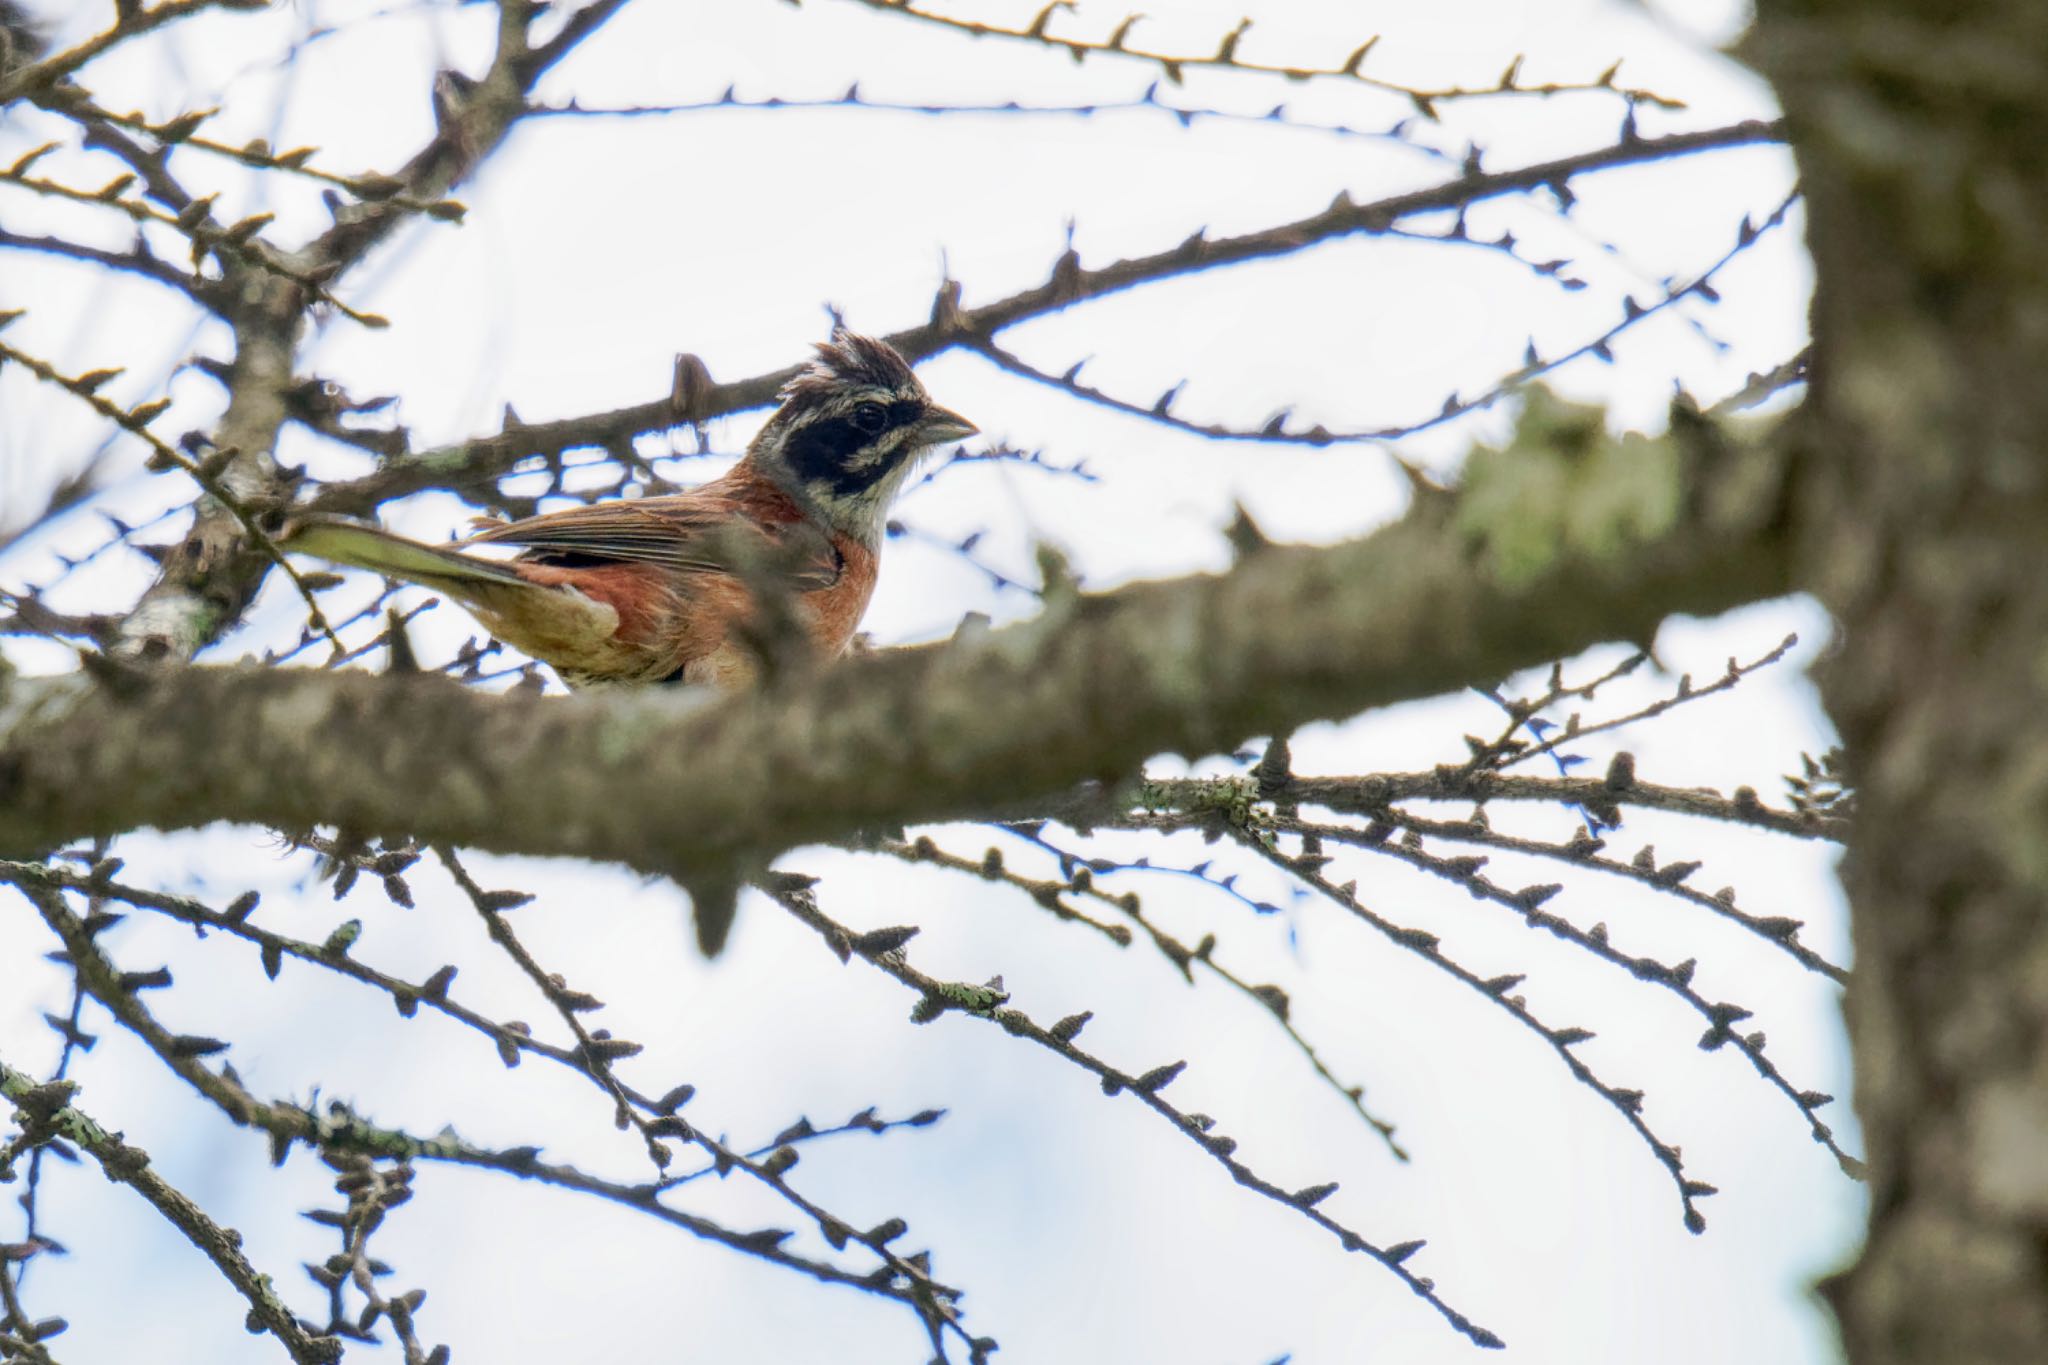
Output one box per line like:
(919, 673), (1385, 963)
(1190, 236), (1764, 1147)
(0, 397), (1790, 880)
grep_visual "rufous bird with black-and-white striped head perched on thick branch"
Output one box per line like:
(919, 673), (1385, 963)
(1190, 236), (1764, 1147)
(279, 327), (979, 692)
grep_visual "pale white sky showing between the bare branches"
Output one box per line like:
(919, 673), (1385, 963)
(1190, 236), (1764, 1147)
(0, 0), (1862, 1365)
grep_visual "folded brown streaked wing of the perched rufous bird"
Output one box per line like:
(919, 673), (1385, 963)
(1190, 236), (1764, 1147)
(469, 485), (842, 591)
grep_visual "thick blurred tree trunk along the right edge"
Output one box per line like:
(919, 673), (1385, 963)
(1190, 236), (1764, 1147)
(1749, 0), (2048, 1365)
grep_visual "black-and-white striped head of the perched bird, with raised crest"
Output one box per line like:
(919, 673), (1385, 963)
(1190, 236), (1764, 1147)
(748, 327), (979, 544)
